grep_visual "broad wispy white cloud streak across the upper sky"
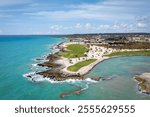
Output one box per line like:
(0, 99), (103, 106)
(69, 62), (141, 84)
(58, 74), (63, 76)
(25, 0), (150, 20)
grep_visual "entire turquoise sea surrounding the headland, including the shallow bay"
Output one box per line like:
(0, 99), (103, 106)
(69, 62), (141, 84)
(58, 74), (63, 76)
(0, 36), (150, 100)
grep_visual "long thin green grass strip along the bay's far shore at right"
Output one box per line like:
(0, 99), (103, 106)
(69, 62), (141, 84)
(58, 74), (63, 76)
(108, 50), (150, 57)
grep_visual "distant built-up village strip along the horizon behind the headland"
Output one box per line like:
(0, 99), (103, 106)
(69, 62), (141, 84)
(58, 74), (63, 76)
(67, 33), (150, 46)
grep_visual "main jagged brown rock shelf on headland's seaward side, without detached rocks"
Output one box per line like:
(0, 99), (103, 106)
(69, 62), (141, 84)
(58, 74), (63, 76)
(37, 53), (84, 81)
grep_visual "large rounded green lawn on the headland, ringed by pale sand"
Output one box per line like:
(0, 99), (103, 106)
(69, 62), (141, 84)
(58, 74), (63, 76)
(60, 44), (88, 58)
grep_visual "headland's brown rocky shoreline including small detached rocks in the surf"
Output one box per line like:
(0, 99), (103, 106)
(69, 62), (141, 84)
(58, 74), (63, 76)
(27, 43), (100, 81)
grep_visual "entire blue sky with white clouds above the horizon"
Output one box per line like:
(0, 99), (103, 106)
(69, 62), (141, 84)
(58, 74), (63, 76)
(0, 0), (150, 35)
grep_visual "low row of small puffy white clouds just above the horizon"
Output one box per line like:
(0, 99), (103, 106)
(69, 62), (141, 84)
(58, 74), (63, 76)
(49, 23), (146, 34)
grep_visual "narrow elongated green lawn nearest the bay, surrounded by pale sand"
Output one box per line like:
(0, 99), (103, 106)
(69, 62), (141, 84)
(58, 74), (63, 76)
(68, 59), (96, 72)
